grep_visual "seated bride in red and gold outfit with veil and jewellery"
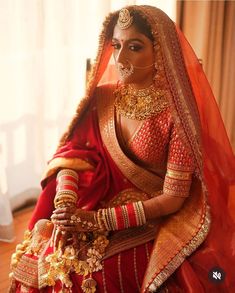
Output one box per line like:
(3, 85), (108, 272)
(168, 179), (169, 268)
(11, 6), (235, 293)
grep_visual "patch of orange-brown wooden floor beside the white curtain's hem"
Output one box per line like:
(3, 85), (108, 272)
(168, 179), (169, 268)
(0, 207), (33, 293)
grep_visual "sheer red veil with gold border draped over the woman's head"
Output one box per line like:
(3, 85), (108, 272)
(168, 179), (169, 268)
(55, 6), (235, 292)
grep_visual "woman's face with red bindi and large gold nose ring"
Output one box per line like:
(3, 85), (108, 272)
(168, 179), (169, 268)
(112, 25), (154, 88)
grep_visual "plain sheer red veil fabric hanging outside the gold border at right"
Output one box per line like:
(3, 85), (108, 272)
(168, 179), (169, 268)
(169, 30), (235, 292)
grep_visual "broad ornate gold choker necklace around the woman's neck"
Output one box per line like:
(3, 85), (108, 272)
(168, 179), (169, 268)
(114, 84), (168, 120)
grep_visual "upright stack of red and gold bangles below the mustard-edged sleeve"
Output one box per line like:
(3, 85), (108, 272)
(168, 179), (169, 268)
(54, 169), (78, 208)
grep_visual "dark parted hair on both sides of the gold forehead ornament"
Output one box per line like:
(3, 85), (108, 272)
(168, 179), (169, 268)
(108, 10), (154, 42)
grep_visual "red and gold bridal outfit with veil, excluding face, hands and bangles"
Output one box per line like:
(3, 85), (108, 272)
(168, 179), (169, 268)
(11, 6), (235, 293)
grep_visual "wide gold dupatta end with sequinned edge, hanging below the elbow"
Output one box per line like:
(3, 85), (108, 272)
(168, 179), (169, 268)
(141, 179), (210, 292)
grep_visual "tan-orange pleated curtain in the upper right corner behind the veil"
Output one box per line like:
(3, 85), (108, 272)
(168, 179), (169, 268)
(177, 0), (235, 150)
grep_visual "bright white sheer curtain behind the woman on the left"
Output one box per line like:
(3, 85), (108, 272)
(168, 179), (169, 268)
(0, 0), (175, 241)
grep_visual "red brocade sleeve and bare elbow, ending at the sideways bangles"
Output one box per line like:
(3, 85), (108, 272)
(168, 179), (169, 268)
(143, 121), (195, 219)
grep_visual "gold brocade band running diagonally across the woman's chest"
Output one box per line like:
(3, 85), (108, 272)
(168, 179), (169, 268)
(96, 85), (163, 194)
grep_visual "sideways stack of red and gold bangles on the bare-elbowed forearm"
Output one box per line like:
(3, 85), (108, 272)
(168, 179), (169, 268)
(97, 201), (146, 231)
